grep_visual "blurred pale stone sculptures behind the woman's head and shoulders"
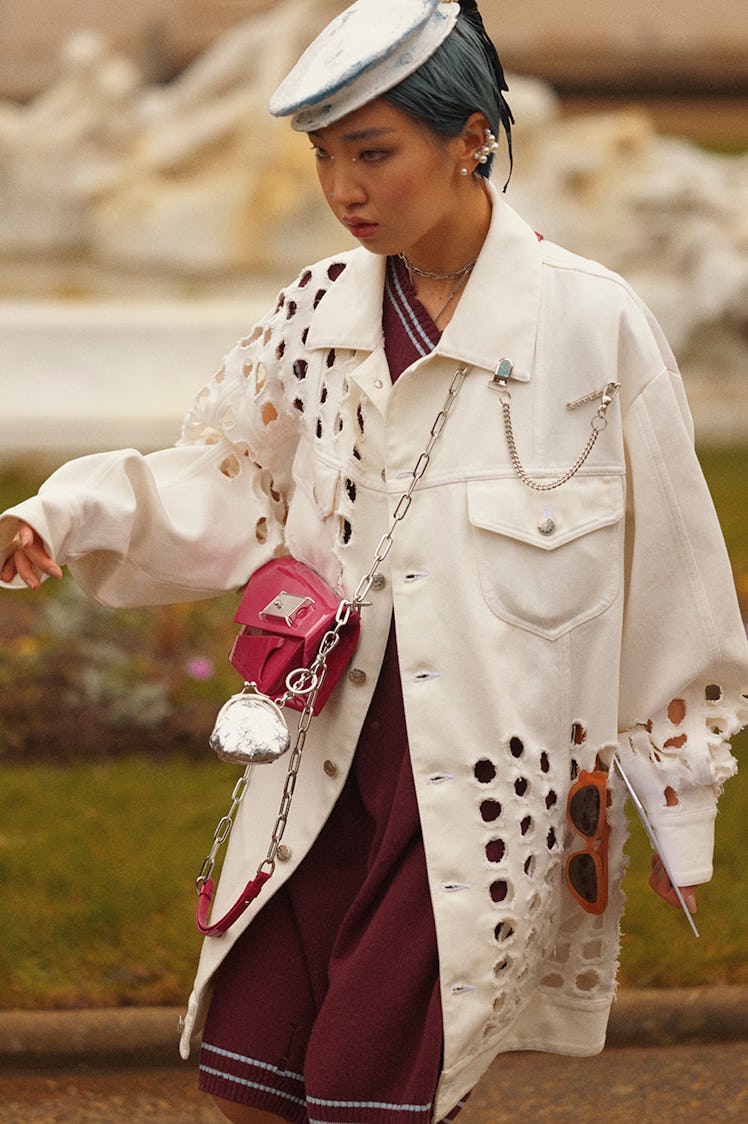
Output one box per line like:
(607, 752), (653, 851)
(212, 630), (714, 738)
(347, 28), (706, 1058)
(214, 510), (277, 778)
(0, 0), (748, 409)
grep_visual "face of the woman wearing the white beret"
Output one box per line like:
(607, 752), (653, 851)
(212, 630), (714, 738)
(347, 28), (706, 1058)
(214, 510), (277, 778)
(309, 99), (485, 263)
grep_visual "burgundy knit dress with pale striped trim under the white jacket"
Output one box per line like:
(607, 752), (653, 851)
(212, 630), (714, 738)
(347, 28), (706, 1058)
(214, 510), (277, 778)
(199, 259), (461, 1124)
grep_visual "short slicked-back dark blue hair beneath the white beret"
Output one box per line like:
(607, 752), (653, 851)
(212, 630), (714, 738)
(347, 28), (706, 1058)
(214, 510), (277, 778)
(382, 3), (514, 190)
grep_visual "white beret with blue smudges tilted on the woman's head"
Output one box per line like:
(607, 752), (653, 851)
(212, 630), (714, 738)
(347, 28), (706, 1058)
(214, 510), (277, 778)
(269, 0), (460, 133)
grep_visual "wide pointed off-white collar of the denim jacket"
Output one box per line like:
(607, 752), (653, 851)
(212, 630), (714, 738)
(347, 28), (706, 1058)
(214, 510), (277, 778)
(307, 183), (542, 381)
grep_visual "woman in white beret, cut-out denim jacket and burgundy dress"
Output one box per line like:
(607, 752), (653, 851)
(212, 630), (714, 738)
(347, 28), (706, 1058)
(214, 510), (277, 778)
(0, 0), (748, 1124)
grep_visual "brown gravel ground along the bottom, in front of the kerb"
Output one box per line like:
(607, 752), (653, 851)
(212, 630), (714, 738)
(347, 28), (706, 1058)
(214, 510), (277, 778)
(0, 1042), (748, 1124)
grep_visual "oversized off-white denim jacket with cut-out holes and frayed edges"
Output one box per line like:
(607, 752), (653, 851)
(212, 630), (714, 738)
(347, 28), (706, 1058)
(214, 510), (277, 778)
(0, 189), (748, 1120)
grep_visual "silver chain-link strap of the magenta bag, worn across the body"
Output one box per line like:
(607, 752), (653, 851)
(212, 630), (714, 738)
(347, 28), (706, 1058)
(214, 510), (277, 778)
(195, 366), (470, 892)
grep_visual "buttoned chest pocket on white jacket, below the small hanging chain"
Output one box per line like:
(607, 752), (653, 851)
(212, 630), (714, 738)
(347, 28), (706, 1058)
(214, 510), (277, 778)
(468, 475), (623, 640)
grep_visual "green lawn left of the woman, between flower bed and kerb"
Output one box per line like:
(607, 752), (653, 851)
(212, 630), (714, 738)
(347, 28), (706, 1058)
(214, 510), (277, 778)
(0, 747), (227, 1008)
